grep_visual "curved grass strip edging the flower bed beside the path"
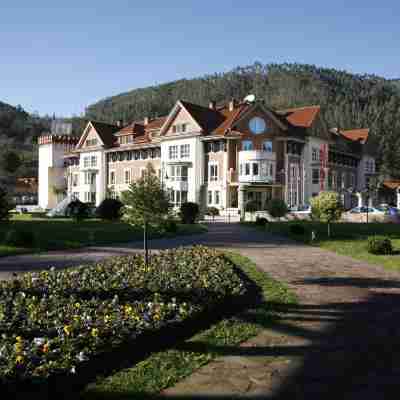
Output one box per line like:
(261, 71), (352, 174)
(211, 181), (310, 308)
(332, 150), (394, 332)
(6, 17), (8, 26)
(82, 253), (296, 400)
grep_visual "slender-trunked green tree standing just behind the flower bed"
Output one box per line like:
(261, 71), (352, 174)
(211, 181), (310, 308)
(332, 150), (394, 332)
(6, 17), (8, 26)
(122, 164), (171, 265)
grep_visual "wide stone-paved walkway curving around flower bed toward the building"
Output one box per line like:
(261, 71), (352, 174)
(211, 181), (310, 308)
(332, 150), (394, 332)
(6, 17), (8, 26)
(0, 224), (400, 400)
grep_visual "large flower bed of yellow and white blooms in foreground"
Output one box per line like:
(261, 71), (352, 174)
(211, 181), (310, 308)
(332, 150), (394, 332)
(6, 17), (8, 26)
(0, 246), (247, 394)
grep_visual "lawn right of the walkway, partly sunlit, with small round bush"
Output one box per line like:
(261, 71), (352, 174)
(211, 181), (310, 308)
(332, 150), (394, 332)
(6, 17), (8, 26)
(266, 222), (400, 271)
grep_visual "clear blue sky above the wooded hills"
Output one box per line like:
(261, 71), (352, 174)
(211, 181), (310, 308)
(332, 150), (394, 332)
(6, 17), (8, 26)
(0, 0), (400, 116)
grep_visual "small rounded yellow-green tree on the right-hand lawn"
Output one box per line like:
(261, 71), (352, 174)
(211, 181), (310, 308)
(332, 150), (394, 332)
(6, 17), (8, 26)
(310, 192), (343, 237)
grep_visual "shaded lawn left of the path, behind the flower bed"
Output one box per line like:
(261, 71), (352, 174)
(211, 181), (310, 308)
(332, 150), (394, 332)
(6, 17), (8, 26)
(0, 215), (207, 256)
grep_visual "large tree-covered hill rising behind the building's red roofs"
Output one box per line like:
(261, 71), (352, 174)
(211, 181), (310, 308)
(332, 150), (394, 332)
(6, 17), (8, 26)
(86, 63), (400, 178)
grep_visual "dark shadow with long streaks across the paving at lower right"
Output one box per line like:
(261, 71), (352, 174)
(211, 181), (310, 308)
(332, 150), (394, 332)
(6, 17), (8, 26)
(79, 278), (400, 400)
